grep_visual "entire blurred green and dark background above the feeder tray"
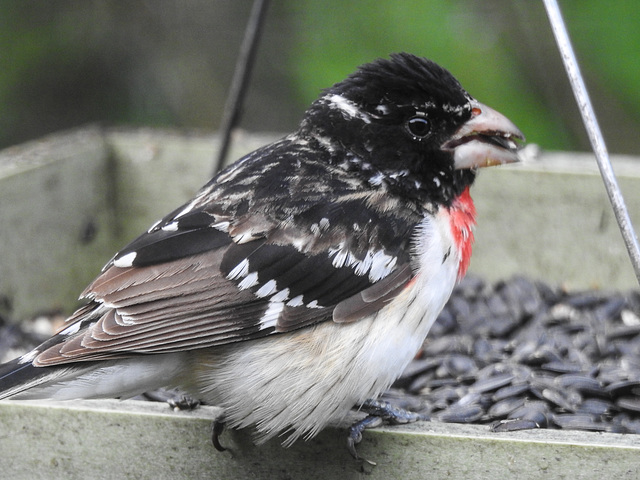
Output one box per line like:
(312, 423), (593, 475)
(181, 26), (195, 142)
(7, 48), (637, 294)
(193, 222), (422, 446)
(0, 0), (640, 154)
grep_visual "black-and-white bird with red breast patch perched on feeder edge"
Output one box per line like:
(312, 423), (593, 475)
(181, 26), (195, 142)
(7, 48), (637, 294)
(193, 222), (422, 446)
(0, 53), (524, 456)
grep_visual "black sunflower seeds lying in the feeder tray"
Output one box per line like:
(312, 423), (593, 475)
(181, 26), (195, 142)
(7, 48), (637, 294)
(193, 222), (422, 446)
(0, 276), (640, 433)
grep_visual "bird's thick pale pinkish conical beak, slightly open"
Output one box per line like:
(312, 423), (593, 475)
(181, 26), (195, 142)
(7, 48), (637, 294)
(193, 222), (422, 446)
(441, 100), (524, 169)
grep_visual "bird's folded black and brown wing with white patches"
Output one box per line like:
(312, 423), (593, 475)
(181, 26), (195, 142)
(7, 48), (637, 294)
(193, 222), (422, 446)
(32, 141), (415, 366)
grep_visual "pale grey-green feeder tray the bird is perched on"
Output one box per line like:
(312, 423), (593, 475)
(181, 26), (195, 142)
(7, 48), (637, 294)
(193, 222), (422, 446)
(0, 127), (640, 479)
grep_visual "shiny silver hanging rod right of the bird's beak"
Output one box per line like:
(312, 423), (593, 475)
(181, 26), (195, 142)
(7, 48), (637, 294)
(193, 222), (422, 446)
(543, 0), (640, 283)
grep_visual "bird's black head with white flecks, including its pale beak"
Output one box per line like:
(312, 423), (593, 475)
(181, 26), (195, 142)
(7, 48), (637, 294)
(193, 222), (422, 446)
(299, 53), (522, 205)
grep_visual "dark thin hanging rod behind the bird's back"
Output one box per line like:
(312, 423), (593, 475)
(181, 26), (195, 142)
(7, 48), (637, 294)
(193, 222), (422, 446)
(213, 0), (269, 175)
